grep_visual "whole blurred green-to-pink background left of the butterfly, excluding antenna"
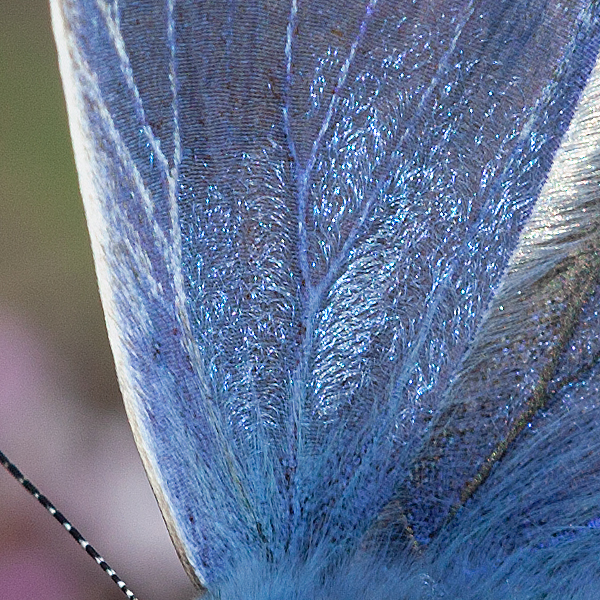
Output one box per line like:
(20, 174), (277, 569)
(0, 0), (193, 600)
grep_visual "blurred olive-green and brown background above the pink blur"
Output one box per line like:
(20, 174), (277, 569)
(0, 0), (114, 404)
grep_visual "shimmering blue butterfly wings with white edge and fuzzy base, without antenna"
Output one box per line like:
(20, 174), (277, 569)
(52, 0), (600, 600)
